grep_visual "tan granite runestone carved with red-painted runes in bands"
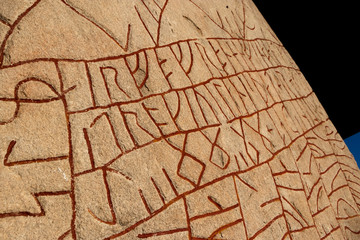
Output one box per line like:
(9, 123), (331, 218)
(0, 0), (360, 240)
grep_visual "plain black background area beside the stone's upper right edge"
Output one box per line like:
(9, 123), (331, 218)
(253, 0), (360, 138)
